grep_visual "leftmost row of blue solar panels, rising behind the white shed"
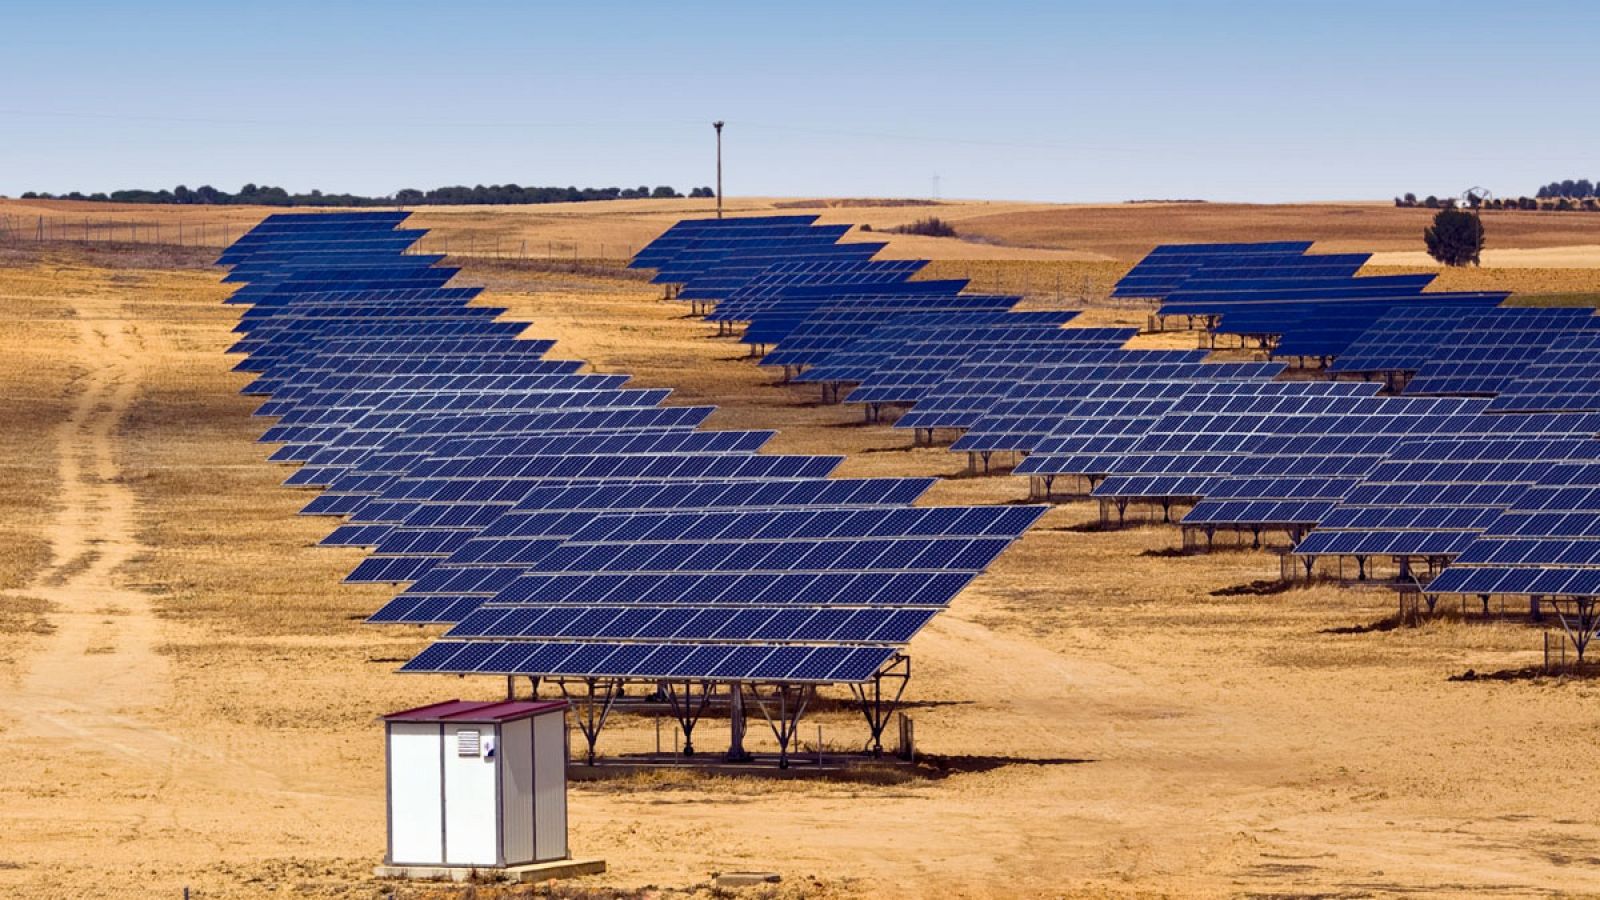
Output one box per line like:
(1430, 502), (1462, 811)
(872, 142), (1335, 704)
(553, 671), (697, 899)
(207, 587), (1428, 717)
(221, 213), (1059, 682)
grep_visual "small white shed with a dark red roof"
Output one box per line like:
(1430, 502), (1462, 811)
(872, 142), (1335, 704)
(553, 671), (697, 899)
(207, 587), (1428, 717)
(384, 700), (568, 868)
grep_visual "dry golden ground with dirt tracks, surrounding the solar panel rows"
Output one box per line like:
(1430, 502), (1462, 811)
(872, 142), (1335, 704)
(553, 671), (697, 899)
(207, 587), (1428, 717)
(0, 202), (1600, 898)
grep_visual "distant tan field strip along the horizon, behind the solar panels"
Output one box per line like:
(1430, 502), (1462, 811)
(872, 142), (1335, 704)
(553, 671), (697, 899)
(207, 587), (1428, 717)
(12, 197), (1600, 269)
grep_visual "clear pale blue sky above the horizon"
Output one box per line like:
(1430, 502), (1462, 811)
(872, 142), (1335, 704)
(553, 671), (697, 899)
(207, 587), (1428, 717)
(0, 0), (1600, 200)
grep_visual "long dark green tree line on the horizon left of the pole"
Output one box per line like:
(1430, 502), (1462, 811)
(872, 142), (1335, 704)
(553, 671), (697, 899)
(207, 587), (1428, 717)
(22, 184), (717, 207)
